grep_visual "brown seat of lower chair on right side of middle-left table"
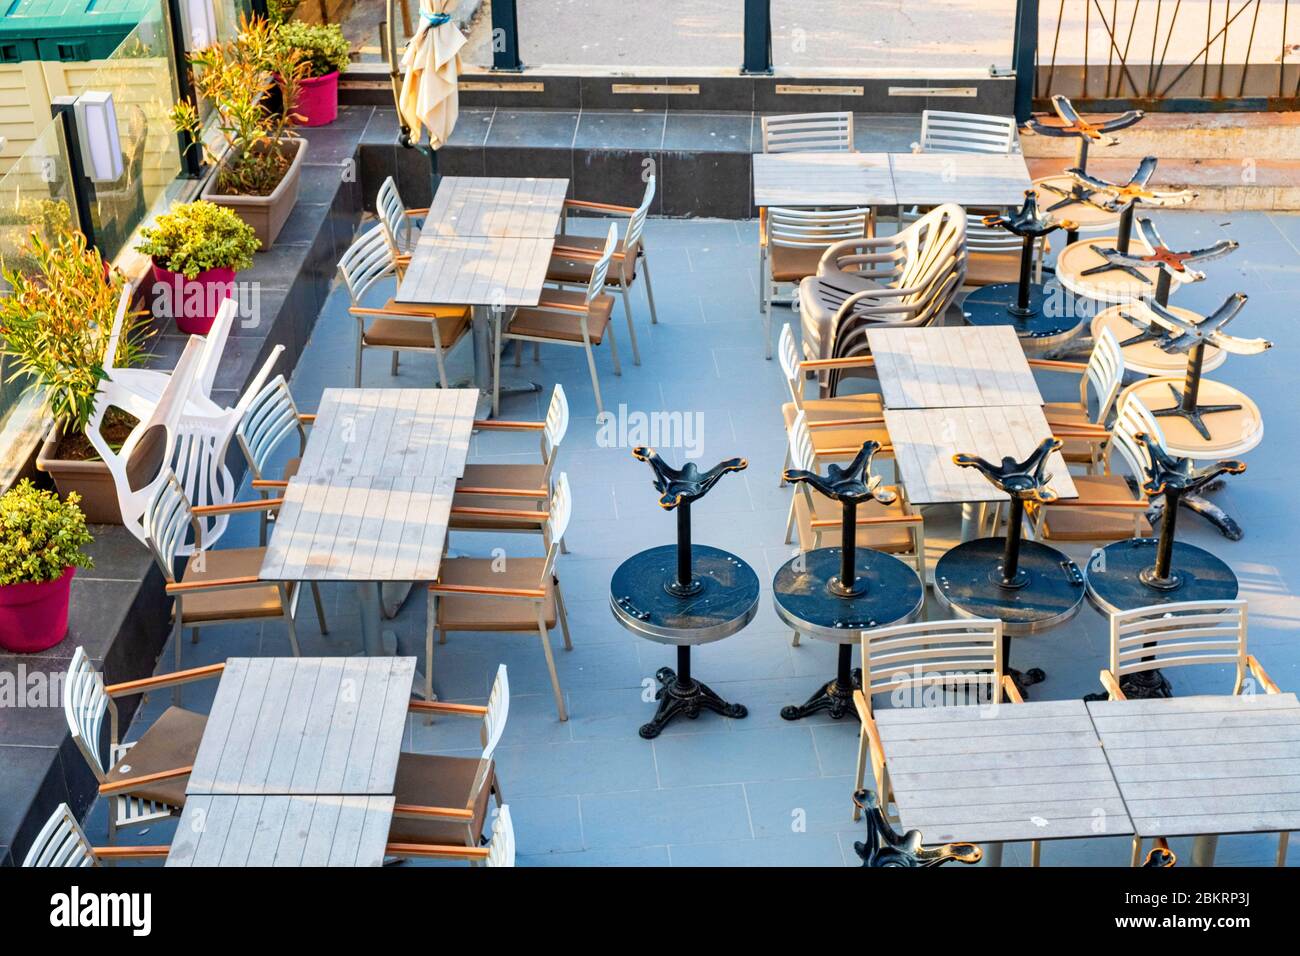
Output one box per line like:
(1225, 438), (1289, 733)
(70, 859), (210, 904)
(433, 558), (555, 631)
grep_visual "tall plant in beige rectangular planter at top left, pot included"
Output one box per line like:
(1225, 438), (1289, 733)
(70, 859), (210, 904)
(172, 18), (307, 248)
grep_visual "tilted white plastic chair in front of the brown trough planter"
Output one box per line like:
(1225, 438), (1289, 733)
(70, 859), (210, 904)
(86, 336), (203, 542)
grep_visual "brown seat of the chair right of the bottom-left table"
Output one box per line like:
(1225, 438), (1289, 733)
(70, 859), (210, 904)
(389, 753), (497, 847)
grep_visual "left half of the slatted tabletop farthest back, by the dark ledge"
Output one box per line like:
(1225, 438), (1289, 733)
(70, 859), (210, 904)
(754, 152), (898, 207)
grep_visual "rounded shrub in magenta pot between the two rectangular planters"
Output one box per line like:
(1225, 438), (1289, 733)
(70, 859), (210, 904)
(135, 199), (261, 336)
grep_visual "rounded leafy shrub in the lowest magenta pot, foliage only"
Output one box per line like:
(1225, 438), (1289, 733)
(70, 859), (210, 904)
(0, 479), (95, 584)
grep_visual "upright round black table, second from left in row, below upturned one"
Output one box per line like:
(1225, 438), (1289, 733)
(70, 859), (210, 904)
(772, 548), (926, 721)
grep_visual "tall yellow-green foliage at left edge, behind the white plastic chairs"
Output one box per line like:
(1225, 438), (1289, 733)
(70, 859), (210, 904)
(0, 229), (148, 434)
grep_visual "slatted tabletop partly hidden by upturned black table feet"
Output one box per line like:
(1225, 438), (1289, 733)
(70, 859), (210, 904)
(885, 405), (1079, 505)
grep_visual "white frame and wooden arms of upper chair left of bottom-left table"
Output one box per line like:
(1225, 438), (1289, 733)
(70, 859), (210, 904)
(60, 648), (225, 843)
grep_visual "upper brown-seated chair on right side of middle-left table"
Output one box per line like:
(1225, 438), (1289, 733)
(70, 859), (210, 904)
(447, 384), (569, 549)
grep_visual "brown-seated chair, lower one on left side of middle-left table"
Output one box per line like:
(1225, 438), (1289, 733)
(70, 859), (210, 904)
(144, 471), (326, 686)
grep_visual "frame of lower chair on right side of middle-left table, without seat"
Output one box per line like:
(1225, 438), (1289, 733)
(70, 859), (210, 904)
(424, 472), (573, 721)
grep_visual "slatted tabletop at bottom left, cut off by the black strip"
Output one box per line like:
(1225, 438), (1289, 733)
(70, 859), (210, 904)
(166, 795), (394, 866)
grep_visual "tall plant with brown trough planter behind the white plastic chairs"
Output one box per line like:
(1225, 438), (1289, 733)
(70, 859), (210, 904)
(0, 229), (147, 524)
